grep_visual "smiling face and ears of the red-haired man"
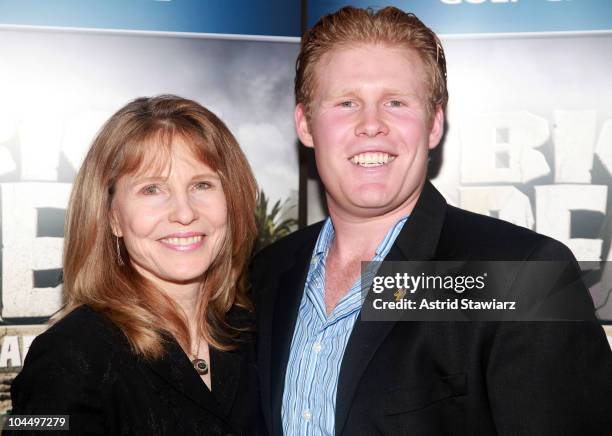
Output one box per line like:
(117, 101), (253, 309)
(295, 44), (444, 218)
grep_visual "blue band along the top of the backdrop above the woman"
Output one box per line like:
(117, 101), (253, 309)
(0, 0), (300, 36)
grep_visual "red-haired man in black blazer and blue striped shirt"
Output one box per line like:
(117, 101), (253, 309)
(252, 7), (612, 435)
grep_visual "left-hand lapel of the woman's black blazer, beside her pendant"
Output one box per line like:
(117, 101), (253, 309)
(145, 337), (229, 424)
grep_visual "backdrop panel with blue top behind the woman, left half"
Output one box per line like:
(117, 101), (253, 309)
(0, 0), (300, 414)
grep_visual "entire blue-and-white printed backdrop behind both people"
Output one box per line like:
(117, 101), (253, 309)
(0, 0), (612, 414)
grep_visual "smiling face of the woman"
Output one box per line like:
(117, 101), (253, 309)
(112, 138), (227, 289)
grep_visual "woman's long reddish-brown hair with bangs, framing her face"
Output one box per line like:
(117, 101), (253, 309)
(63, 95), (257, 358)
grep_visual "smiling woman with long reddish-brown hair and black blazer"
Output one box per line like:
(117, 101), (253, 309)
(11, 95), (258, 436)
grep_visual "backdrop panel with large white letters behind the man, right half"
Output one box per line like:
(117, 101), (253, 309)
(308, 0), (612, 323)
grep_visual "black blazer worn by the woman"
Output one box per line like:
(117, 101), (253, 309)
(11, 306), (259, 436)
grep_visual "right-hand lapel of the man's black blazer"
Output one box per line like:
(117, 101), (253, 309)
(335, 181), (446, 435)
